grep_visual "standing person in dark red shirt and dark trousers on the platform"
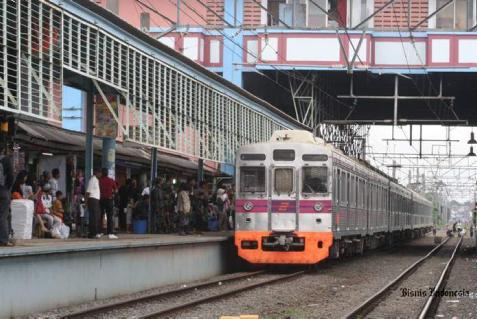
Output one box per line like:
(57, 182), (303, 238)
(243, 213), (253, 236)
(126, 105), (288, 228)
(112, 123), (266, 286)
(99, 168), (118, 239)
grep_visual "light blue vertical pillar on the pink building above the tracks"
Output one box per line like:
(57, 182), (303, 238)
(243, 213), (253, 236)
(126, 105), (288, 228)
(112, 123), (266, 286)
(222, 0), (244, 87)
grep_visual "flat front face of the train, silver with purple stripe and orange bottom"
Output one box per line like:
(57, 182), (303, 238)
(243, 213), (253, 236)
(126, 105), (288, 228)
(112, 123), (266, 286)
(235, 143), (333, 264)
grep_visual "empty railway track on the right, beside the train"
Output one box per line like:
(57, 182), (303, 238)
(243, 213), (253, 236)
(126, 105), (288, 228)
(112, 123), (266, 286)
(344, 237), (463, 319)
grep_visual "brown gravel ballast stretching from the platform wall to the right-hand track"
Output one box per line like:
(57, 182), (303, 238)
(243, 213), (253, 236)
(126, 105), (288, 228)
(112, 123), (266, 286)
(30, 236), (462, 319)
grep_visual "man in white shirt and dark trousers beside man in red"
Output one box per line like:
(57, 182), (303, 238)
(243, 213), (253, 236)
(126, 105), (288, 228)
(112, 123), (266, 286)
(86, 168), (101, 238)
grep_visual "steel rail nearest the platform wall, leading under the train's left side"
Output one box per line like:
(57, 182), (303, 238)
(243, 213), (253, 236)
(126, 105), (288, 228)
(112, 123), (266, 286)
(61, 270), (266, 318)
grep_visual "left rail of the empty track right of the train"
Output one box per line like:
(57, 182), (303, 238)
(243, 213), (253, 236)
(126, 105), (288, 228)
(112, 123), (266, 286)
(343, 237), (450, 319)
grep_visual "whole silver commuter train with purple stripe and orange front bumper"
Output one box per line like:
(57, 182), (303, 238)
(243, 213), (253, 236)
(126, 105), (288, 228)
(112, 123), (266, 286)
(235, 130), (432, 264)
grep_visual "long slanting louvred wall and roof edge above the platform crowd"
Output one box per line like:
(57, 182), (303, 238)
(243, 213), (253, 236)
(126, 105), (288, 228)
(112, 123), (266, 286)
(0, 0), (307, 168)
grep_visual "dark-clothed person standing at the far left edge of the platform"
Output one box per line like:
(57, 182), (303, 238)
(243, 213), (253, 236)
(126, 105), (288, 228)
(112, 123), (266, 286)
(0, 150), (15, 246)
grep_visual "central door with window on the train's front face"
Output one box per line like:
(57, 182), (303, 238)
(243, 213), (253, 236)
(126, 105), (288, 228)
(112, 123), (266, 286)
(270, 166), (298, 232)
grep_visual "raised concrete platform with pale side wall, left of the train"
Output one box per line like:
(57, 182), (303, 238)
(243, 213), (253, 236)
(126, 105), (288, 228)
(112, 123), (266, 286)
(0, 232), (238, 318)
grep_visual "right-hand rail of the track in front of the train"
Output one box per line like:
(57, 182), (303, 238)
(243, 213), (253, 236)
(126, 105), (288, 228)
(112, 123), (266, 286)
(137, 270), (305, 319)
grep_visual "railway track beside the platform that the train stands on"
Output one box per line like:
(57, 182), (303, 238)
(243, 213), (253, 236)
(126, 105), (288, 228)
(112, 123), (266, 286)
(62, 270), (305, 319)
